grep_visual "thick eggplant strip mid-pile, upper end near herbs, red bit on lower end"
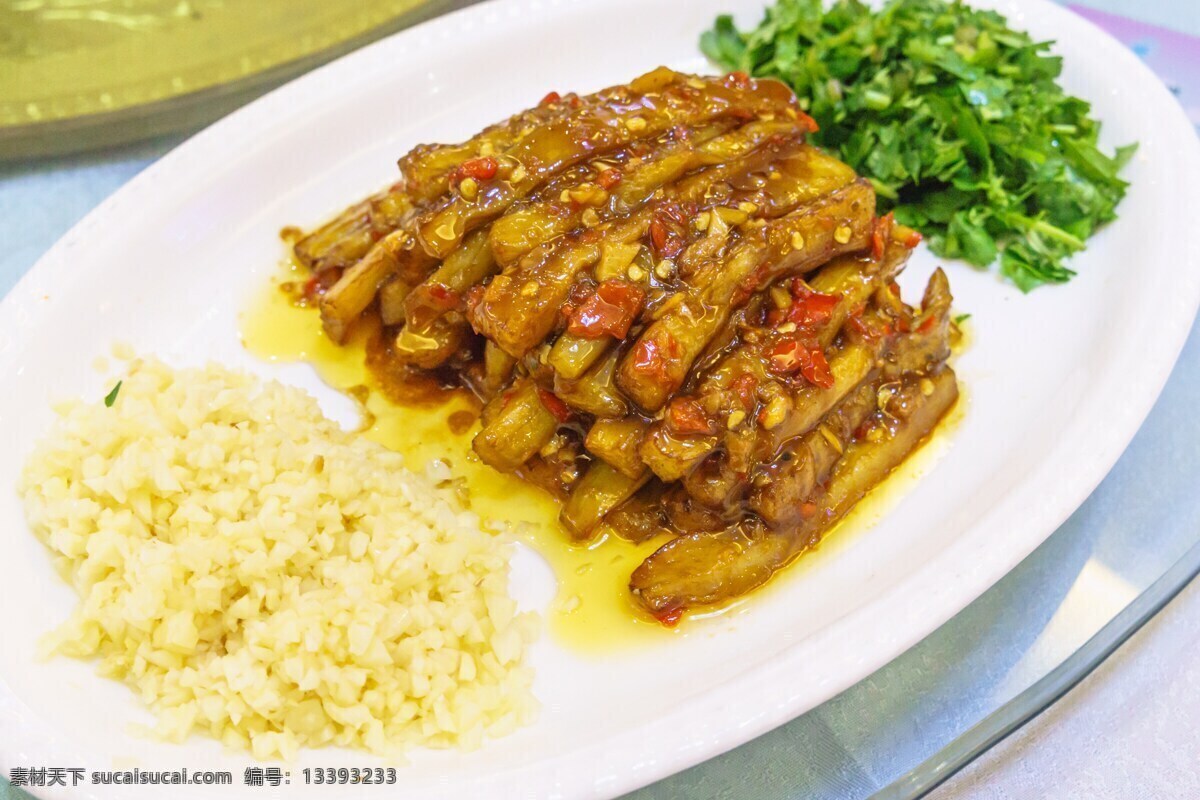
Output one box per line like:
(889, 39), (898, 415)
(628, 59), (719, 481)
(617, 181), (875, 411)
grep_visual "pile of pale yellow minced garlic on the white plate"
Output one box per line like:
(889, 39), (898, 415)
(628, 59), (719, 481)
(19, 360), (536, 758)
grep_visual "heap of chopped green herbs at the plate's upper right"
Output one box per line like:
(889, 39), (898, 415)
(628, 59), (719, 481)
(701, 0), (1136, 291)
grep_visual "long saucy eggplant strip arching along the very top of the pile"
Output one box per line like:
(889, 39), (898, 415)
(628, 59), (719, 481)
(418, 73), (796, 258)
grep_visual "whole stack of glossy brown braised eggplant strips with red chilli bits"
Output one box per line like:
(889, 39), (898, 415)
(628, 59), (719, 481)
(288, 68), (958, 625)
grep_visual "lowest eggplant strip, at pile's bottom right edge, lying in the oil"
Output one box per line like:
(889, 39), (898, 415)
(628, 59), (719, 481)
(629, 369), (958, 621)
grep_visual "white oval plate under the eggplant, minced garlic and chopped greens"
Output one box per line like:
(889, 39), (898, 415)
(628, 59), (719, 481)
(0, 0), (1200, 800)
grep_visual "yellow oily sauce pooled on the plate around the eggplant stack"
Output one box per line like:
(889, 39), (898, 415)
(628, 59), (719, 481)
(241, 265), (965, 652)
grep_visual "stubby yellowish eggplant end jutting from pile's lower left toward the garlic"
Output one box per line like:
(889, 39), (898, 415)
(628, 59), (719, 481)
(472, 380), (559, 473)
